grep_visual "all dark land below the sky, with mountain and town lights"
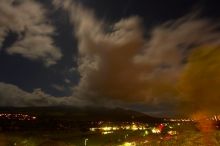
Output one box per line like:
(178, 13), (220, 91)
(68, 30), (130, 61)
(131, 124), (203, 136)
(0, 107), (220, 146)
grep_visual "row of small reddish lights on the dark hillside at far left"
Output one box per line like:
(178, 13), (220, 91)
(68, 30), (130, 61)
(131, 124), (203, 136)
(0, 113), (36, 121)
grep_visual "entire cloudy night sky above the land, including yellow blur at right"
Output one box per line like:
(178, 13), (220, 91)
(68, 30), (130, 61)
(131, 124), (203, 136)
(0, 0), (220, 115)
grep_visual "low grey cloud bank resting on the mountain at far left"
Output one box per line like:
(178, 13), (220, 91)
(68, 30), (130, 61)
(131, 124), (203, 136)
(0, 82), (84, 107)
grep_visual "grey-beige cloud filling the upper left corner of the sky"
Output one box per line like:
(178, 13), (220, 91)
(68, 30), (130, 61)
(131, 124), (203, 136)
(0, 0), (62, 66)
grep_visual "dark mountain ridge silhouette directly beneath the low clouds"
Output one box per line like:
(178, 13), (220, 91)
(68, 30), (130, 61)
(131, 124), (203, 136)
(0, 107), (162, 122)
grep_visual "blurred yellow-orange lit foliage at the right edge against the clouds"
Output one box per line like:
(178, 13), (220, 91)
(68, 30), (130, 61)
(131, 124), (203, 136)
(179, 46), (220, 112)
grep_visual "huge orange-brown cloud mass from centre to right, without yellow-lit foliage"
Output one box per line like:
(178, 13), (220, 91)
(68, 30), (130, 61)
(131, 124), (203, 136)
(54, 0), (220, 114)
